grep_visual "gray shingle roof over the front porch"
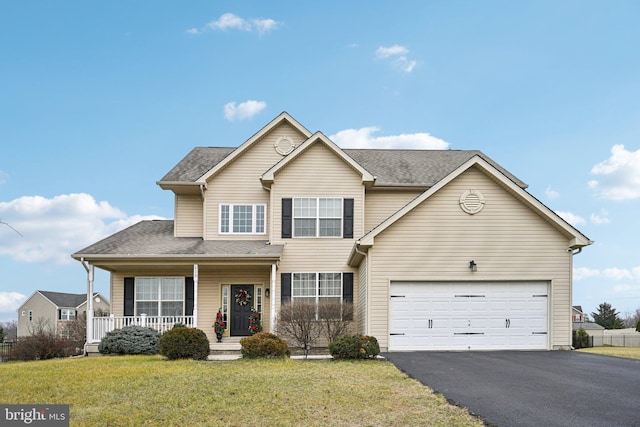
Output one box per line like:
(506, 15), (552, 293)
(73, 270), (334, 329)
(72, 220), (283, 259)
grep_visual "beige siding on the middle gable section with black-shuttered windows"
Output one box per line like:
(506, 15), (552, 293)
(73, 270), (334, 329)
(270, 142), (364, 309)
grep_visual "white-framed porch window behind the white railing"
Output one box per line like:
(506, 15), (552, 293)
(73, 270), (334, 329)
(135, 277), (184, 316)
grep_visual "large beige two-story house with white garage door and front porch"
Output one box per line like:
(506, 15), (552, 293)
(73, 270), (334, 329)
(72, 112), (592, 351)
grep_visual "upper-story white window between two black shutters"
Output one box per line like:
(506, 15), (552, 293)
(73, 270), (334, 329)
(293, 197), (342, 237)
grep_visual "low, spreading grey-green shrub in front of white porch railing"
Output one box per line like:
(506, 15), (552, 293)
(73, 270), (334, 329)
(98, 326), (160, 354)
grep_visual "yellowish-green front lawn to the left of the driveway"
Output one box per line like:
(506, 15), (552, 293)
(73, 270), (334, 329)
(0, 356), (482, 426)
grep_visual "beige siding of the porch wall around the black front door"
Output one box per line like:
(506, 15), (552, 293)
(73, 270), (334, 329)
(111, 265), (271, 343)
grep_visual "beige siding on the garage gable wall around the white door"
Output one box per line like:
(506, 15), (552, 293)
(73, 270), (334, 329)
(368, 168), (571, 348)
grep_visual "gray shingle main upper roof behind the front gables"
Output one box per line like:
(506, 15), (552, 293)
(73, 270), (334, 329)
(160, 147), (527, 188)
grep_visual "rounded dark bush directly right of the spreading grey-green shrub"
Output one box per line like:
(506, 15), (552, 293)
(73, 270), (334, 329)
(158, 327), (209, 360)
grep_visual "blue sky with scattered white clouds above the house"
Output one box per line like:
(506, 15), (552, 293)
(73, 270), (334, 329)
(0, 0), (640, 321)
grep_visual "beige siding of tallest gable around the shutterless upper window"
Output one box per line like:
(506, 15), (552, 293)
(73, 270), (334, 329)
(204, 123), (303, 240)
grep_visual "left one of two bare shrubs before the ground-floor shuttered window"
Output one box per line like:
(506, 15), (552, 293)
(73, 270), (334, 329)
(278, 301), (322, 358)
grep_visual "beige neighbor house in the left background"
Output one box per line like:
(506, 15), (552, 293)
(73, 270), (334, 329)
(18, 291), (110, 337)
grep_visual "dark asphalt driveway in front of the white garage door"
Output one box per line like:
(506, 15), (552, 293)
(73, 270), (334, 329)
(384, 351), (640, 427)
